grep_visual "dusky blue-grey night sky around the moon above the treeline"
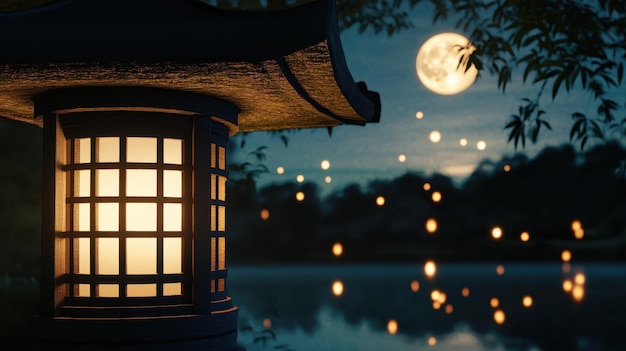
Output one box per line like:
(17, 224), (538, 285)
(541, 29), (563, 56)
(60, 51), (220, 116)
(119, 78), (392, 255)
(236, 4), (595, 197)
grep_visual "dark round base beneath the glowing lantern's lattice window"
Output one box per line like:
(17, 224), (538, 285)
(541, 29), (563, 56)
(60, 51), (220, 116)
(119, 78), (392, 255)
(29, 307), (238, 351)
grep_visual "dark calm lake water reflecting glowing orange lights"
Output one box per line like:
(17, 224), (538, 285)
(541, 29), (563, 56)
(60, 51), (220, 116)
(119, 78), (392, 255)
(228, 263), (626, 351)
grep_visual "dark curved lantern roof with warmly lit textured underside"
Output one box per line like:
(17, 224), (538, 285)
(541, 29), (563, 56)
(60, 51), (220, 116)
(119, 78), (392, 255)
(0, 0), (380, 133)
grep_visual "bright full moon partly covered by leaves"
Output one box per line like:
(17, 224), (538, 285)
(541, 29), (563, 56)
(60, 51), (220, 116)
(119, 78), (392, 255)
(415, 32), (478, 95)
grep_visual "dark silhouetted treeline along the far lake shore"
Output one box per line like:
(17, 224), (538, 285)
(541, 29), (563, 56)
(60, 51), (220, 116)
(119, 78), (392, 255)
(227, 143), (626, 263)
